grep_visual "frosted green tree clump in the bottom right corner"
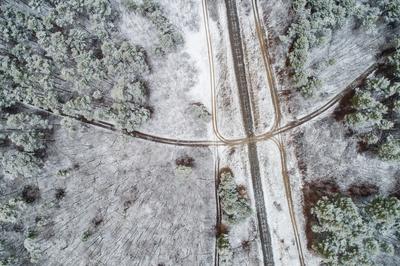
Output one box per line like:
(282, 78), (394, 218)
(311, 196), (400, 265)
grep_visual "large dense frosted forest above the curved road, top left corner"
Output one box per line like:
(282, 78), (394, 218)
(0, 0), (150, 130)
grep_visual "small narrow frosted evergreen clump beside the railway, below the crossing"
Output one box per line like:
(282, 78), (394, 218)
(218, 171), (251, 224)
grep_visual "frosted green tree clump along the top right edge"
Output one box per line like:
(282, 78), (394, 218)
(283, 0), (400, 97)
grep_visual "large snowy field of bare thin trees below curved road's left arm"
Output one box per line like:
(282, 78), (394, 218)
(38, 126), (215, 265)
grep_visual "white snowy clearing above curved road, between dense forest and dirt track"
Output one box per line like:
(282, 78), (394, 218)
(121, 1), (211, 139)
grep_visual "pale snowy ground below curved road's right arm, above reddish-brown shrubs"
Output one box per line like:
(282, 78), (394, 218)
(292, 117), (400, 195)
